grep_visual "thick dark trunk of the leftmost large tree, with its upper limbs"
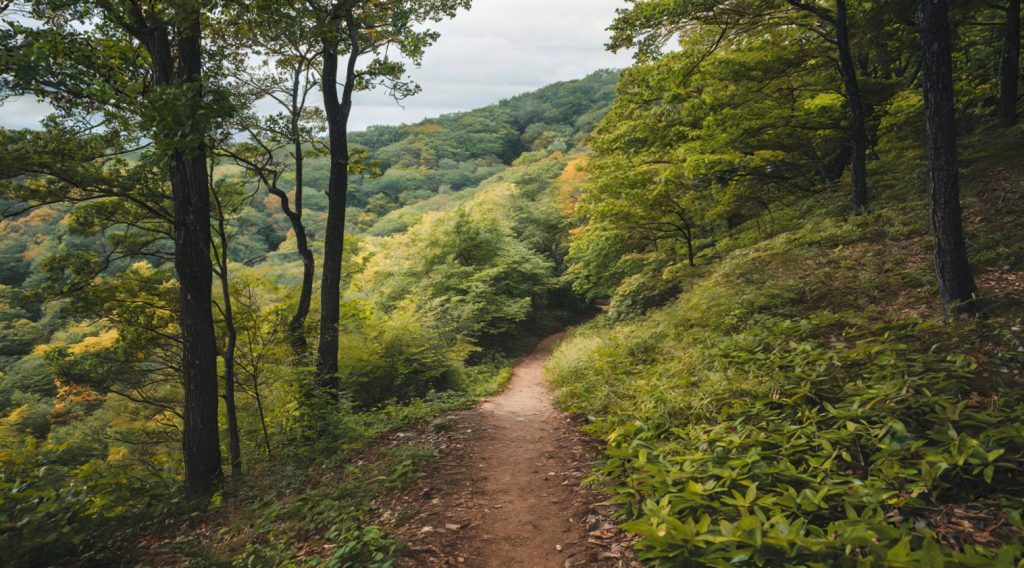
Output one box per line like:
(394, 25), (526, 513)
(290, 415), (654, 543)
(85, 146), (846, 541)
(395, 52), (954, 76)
(105, 1), (223, 495)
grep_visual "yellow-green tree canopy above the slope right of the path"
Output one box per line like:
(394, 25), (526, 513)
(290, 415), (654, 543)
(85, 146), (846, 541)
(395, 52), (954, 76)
(567, 0), (1011, 317)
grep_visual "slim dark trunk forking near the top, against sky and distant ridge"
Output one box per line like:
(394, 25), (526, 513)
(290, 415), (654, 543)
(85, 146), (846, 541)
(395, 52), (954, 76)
(316, 17), (358, 391)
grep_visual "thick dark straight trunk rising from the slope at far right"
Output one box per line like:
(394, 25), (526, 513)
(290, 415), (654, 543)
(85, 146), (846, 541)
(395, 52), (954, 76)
(918, 0), (976, 304)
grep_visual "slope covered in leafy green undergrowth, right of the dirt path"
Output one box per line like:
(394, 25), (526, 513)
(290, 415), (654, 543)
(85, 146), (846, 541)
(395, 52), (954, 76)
(547, 130), (1024, 566)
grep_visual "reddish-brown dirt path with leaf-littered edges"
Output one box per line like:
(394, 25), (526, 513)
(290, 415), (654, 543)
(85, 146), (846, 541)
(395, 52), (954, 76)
(368, 334), (639, 568)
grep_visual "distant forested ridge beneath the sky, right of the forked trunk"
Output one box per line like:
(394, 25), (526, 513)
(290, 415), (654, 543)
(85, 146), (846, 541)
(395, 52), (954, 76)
(352, 71), (618, 225)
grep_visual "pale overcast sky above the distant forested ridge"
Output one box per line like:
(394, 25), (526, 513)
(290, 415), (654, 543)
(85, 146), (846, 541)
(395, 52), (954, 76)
(0, 0), (629, 130)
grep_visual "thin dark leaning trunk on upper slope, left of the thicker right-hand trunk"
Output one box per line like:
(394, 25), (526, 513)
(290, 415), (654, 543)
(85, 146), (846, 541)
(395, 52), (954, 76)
(836, 0), (867, 211)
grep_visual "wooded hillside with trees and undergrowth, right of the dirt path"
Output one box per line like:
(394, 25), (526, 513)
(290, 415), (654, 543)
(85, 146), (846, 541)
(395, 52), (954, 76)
(548, 0), (1024, 566)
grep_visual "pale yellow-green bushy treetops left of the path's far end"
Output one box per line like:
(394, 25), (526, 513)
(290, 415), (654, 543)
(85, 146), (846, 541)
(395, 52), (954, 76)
(357, 185), (553, 345)
